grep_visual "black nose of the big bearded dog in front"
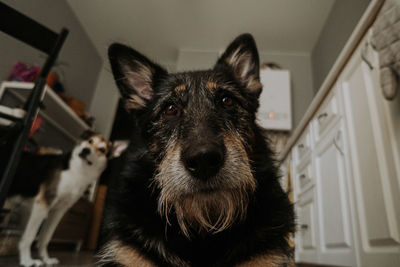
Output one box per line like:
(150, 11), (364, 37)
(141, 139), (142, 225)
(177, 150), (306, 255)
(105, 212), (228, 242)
(183, 145), (224, 180)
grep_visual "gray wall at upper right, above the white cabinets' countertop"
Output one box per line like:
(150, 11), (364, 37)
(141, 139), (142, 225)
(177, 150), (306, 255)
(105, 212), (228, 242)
(311, 0), (370, 92)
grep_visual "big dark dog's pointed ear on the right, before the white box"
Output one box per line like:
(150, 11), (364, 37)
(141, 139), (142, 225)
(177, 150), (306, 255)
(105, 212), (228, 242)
(214, 33), (262, 97)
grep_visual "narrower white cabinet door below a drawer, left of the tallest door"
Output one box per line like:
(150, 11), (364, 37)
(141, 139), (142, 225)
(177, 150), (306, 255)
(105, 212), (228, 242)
(314, 120), (356, 266)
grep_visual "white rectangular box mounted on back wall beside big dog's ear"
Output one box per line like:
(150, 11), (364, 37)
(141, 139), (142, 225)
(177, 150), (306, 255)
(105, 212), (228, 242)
(257, 69), (292, 131)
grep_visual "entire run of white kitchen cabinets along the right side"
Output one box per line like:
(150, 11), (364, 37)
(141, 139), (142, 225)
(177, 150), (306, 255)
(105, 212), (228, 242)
(289, 30), (400, 267)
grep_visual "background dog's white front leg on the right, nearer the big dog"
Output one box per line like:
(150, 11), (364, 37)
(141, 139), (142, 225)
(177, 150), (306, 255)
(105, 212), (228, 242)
(38, 201), (73, 265)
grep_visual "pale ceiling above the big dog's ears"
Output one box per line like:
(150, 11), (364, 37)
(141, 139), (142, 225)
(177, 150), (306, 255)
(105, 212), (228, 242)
(67, 0), (334, 63)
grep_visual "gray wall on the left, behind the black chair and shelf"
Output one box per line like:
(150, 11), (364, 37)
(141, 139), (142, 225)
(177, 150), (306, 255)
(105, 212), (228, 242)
(0, 0), (102, 109)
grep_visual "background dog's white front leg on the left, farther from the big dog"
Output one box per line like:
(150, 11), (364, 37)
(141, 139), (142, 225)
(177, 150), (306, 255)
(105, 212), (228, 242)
(18, 197), (48, 266)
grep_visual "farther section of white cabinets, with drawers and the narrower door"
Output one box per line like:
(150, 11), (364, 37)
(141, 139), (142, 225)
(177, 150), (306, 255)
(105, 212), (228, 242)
(292, 91), (356, 266)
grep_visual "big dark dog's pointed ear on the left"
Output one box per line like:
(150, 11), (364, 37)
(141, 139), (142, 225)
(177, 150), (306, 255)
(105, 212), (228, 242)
(108, 43), (167, 110)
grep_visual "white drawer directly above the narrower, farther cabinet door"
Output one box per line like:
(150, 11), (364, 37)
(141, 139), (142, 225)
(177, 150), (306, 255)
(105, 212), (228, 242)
(314, 91), (340, 140)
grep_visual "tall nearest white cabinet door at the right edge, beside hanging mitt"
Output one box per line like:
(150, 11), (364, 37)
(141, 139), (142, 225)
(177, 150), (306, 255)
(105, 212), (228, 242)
(341, 38), (400, 266)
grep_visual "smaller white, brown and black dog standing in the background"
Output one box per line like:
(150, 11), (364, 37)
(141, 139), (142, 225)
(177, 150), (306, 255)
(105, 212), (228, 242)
(9, 132), (127, 266)
